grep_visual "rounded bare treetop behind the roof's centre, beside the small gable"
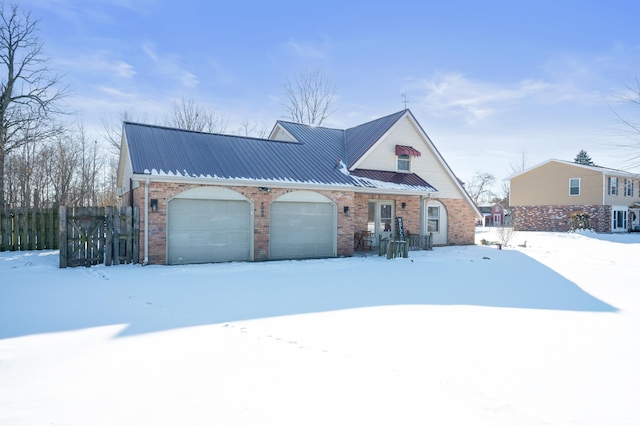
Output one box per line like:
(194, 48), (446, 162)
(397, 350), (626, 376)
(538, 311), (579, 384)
(284, 70), (338, 126)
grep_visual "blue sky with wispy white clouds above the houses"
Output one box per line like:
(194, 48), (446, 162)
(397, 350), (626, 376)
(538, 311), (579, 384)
(19, 0), (640, 187)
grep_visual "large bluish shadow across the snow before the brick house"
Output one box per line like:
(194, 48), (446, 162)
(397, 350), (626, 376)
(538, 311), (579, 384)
(0, 246), (617, 339)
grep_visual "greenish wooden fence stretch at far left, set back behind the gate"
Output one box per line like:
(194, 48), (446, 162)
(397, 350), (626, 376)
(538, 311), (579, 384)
(0, 209), (59, 251)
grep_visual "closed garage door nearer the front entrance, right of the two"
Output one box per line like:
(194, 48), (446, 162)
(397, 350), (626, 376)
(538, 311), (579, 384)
(269, 201), (336, 260)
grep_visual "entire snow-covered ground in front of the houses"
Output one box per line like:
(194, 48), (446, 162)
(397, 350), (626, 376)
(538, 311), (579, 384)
(0, 230), (640, 426)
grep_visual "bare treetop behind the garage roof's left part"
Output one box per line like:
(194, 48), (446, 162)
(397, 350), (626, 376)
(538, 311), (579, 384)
(165, 98), (228, 133)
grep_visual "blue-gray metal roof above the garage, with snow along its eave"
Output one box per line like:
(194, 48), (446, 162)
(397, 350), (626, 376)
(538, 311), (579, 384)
(124, 114), (435, 192)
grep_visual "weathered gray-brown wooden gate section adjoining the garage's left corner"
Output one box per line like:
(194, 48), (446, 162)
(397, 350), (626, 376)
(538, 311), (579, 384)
(60, 207), (140, 268)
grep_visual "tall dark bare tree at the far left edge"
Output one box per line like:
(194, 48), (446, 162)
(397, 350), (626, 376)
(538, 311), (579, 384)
(0, 3), (66, 207)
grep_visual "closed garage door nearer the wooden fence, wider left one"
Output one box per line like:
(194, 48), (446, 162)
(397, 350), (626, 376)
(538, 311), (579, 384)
(167, 198), (252, 265)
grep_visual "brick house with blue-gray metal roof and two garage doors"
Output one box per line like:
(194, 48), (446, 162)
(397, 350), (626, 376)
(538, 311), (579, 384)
(118, 110), (480, 264)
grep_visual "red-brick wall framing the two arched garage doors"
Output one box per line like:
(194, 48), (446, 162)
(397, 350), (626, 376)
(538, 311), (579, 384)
(128, 182), (354, 264)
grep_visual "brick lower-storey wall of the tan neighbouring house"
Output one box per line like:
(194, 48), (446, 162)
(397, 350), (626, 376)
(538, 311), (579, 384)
(513, 205), (611, 233)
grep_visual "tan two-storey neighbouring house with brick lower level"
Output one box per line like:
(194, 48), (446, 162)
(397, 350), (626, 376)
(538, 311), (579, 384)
(509, 159), (640, 233)
